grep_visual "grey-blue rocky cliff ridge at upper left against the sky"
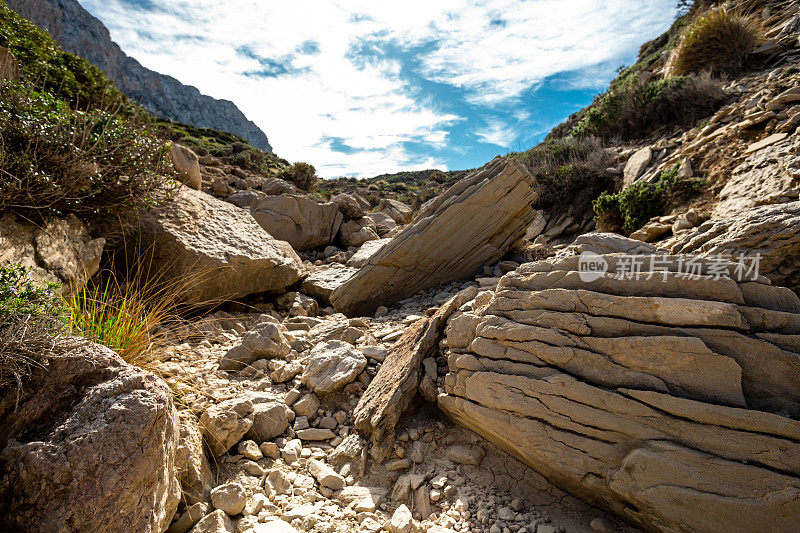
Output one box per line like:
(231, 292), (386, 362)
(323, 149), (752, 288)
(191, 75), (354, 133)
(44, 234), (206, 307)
(8, 0), (272, 153)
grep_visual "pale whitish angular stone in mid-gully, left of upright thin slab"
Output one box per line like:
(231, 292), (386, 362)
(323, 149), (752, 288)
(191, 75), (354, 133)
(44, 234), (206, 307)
(300, 340), (367, 394)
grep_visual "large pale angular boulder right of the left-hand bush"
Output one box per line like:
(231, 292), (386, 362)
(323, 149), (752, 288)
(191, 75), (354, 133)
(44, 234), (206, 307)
(140, 187), (304, 302)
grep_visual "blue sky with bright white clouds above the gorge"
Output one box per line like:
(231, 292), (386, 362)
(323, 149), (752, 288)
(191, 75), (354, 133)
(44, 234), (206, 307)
(79, 0), (675, 178)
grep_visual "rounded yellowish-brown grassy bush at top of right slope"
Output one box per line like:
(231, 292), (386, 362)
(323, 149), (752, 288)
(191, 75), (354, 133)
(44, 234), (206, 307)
(671, 6), (760, 77)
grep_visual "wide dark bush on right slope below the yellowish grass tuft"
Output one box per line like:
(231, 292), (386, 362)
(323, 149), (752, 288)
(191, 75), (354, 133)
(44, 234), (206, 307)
(571, 74), (724, 140)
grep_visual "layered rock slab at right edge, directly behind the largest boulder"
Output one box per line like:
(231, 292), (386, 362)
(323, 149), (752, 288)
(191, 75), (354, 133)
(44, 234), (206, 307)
(670, 202), (800, 291)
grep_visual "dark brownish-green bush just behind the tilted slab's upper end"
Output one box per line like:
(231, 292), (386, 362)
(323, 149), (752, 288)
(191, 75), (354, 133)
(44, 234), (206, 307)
(515, 136), (617, 213)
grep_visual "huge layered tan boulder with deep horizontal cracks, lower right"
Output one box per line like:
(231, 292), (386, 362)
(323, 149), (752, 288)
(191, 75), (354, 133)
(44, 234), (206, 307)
(439, 236), (800, 532)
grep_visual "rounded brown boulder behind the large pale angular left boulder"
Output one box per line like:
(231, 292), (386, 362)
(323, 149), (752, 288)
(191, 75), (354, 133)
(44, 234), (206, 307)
(252, 194), (344, 250)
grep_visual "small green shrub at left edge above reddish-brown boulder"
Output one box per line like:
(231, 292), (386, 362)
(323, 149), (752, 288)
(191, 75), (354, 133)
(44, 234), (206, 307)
(0, 265), (65, 394)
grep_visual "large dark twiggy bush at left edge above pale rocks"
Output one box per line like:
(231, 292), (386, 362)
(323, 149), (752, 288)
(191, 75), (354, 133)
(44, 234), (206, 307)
(0, 84), (171, 222)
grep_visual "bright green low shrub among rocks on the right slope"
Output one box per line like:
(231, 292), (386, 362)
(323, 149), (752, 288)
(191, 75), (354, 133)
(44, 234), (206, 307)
(592, 161), (706, 235)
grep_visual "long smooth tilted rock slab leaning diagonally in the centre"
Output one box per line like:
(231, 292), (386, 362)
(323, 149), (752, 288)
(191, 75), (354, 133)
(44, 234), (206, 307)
(331, 158), (537, 316)
